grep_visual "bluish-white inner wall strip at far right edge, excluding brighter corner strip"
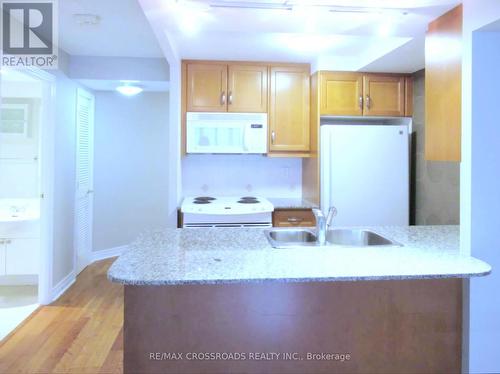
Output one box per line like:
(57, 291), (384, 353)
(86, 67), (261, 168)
(469, 30), (500, 373)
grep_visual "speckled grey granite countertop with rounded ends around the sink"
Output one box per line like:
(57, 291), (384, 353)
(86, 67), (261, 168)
(108, 226), (491, 285)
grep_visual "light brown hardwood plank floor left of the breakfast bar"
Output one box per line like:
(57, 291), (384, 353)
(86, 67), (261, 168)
(0, 259), (123, 373)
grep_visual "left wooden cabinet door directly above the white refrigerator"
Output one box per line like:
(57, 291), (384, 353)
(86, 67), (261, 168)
(320, 72), (363, 116)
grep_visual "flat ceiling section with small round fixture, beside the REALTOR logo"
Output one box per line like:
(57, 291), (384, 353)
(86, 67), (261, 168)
(59, 0), (163, 57)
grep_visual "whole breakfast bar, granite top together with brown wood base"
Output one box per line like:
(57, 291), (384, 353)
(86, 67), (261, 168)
(108, 226), (491, 373)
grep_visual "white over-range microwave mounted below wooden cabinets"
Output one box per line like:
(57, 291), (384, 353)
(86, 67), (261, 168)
(186, 112), (267, 154)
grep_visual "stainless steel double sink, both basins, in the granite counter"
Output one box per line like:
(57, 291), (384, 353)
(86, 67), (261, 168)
(265, 228), (400, 248)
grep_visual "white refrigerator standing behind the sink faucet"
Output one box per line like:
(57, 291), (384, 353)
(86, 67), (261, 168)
(320, 122), (411, 226)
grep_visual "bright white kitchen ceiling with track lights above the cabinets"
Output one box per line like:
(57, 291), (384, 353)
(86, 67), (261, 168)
(139, 0), (460, 72)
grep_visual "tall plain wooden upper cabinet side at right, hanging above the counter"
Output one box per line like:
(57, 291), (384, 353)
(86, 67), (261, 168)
(425, 5), (460, 161)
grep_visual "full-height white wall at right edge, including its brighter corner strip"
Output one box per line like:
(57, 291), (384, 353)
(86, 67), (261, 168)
(460, 0), (500, 373)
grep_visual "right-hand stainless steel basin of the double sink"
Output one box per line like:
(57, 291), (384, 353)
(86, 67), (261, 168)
(326, 229), (400, 247)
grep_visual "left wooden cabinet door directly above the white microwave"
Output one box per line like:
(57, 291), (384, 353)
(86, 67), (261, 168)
(186, 63), (227, 112)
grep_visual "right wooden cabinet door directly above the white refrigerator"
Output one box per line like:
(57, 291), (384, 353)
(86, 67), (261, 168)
(363, 74), (405, 117)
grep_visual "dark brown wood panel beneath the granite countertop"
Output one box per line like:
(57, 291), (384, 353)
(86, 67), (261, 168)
(124, 279), (462, 374)
